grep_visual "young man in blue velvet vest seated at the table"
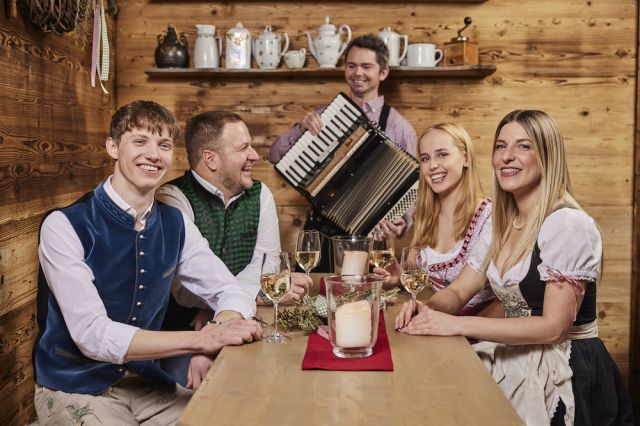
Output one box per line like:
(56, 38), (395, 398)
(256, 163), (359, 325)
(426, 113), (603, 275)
(34, 101), (262, 425)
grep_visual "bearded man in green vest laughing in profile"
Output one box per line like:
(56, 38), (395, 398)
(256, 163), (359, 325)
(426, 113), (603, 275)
(156, 111), (311, 389)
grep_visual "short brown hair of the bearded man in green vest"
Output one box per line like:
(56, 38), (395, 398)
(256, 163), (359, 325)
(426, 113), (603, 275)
(184, 111), (242, 169)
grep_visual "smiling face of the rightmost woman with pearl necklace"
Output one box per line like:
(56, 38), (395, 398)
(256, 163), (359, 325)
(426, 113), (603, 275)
(493, 121), (541, 196)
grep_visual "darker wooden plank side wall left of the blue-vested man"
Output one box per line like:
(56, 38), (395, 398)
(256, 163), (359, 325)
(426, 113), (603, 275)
(0, 0), (115, 425)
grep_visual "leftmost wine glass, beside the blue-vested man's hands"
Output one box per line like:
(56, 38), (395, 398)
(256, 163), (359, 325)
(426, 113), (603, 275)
(260, 251), (291, 343)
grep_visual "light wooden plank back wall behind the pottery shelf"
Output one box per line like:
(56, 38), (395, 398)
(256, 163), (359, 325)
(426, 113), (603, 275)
(117, 0), (637, 380)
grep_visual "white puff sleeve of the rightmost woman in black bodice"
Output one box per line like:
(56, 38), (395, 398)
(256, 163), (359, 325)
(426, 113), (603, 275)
(538, 208), (602, 281)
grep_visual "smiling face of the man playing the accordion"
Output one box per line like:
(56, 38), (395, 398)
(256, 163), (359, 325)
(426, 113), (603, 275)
(344, 46), (389, 102)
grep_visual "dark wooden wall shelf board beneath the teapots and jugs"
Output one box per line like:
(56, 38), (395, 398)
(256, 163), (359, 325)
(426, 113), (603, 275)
(144, 65), (496, 79)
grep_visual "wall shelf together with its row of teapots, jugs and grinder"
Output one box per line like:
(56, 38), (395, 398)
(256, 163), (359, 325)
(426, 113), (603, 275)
(145, 17), (496, 78)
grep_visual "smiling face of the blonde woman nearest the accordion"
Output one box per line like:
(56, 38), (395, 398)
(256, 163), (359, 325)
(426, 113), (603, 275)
(419, 129), (467, 196)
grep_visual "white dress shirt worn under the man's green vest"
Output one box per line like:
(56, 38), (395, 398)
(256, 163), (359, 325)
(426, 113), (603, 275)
(156, 170), (280, 307)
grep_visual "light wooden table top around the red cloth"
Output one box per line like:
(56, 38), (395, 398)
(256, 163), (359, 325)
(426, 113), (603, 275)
(178, 282), (522, 426)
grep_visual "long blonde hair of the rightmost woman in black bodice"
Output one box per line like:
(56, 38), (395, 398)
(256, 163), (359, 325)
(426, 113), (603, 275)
(484, 110), (582, 273)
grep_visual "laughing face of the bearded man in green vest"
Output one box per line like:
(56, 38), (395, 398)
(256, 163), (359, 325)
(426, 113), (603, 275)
(209, 121), (260, 201)
